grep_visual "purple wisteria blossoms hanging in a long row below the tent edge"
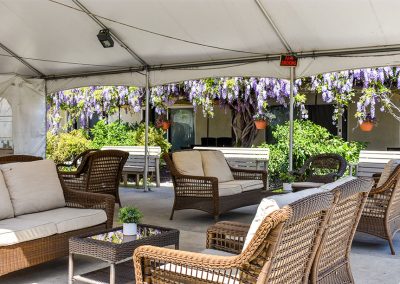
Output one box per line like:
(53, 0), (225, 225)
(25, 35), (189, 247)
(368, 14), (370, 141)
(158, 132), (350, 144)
(48, 67), (400, 132)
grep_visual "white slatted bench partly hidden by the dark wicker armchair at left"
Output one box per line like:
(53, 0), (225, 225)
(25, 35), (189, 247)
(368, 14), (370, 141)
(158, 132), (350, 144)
(102, 146), (161, 187)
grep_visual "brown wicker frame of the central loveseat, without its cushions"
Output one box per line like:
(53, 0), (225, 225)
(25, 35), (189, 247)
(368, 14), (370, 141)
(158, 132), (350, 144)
(163, 154), (273, 220)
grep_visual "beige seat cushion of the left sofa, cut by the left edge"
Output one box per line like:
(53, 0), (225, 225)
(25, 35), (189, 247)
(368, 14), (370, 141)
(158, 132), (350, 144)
(0, 217), (57, 246)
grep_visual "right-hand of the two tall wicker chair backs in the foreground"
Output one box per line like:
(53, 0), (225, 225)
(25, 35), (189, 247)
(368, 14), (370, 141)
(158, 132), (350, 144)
(310, 178), (373, 284)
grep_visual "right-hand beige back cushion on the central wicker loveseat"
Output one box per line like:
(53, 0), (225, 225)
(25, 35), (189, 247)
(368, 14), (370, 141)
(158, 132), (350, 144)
(200, 151), (234, 182)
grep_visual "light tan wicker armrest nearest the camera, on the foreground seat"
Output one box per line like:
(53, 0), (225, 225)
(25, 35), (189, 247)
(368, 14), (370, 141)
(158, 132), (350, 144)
(133, 246), (244, 284)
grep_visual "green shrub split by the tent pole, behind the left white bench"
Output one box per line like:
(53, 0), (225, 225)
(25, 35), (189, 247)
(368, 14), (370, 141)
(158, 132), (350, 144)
(131, 123), (171, 153)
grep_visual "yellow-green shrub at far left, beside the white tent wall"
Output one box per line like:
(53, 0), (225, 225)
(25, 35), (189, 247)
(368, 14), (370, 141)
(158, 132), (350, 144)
(46, 130), (91, 163)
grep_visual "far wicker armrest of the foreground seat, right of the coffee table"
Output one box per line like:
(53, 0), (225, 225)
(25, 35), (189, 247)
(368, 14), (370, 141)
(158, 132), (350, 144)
(206, 221), (250, 254)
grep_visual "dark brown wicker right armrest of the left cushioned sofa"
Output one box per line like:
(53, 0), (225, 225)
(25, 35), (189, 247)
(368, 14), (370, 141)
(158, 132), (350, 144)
(64, 189), (115, 228)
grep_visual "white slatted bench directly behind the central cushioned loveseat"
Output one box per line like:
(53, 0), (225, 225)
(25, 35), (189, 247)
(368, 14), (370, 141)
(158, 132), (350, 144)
(193, 147), (269, 189)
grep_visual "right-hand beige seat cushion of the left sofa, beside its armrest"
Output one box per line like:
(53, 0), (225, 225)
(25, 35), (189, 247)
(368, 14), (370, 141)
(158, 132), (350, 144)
(18, 207), (107, 234)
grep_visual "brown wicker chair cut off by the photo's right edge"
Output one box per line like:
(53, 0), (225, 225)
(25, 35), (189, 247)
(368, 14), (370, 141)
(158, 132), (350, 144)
(357, 165), (400, 255)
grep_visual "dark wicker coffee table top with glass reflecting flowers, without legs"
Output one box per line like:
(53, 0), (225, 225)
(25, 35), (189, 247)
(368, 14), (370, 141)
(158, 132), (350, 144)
(69, 224), (179, 262)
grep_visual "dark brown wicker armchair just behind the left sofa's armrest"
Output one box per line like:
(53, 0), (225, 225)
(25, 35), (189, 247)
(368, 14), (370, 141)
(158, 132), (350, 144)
(59, 150), (129, 206)
